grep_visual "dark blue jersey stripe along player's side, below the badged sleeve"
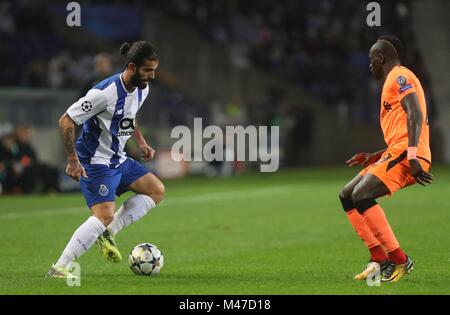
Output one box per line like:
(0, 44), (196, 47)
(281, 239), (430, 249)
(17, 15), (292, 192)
(76, 116), (102, 163)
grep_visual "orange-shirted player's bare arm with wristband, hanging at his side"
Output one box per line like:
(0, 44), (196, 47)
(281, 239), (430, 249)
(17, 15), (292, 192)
(400, 92), (433, 186)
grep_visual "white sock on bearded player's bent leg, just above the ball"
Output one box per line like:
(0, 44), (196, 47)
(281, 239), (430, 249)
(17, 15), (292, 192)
(108, 195), (156, 234)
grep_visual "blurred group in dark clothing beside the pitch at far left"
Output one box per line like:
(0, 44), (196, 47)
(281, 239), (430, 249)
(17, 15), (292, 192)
(0, 125), (59, 195)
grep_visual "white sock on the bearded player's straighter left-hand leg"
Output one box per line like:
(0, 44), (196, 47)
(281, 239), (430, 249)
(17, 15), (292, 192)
(55, 216), (106, 267)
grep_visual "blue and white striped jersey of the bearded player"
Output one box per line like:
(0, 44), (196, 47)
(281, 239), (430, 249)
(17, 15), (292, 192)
(66, 73), (149, 167)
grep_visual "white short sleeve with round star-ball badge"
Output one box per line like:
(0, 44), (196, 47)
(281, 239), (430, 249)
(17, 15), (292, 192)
(66, 89), (108, 125)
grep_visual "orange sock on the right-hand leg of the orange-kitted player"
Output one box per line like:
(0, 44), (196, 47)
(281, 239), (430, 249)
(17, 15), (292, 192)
(363, 204), (406, 263)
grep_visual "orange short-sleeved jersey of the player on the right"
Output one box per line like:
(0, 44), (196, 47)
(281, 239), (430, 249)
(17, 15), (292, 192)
(380, 66), (431, 163)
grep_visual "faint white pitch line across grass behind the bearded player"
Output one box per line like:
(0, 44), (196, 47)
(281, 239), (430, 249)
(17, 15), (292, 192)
(0, 185), (306, 220)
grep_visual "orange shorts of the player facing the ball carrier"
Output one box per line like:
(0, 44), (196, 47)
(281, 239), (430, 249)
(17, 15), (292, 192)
(359, 149), (431, 195)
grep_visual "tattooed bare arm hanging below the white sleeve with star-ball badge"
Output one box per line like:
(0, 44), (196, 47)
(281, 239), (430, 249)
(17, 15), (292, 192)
(59, 113), (87, 181)
